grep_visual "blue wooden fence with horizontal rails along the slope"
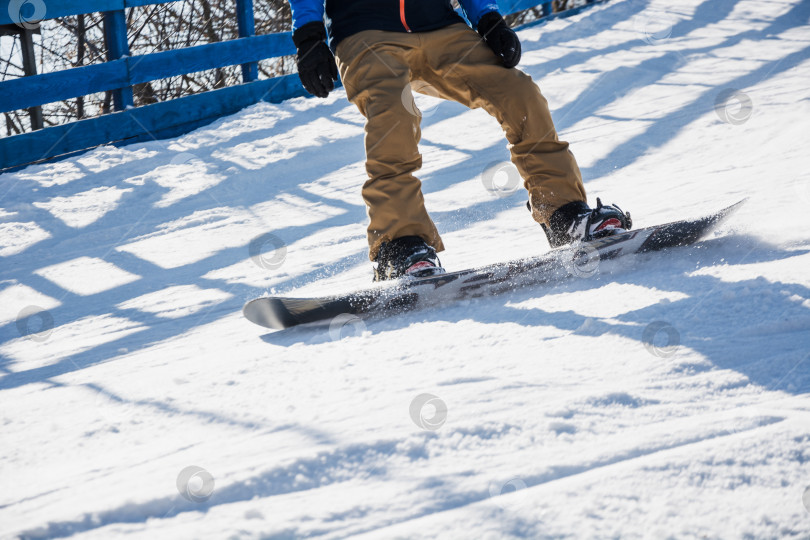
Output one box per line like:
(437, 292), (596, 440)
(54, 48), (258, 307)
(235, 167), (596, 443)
(0, 0), (592, 171)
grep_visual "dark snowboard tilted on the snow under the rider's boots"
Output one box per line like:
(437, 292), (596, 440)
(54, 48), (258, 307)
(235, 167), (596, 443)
(242, 199), (747, 330)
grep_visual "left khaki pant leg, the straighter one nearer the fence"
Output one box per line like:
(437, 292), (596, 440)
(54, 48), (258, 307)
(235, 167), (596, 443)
(336, 30), (444, 261)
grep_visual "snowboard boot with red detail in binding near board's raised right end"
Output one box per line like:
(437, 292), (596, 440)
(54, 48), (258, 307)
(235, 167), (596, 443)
(543, 198), (633, 248)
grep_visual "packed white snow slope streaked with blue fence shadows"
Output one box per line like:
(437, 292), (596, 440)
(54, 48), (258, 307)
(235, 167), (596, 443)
(0, 0), (810, 539)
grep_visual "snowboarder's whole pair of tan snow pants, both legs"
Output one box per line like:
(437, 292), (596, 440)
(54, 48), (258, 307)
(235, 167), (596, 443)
(336, 23), (585, 261)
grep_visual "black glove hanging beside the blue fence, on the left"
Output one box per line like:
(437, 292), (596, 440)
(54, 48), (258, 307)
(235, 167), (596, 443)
(293, 21), (337, 97)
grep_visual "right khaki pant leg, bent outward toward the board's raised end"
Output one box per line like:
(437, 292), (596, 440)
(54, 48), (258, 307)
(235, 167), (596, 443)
(414, 24), (586, 224)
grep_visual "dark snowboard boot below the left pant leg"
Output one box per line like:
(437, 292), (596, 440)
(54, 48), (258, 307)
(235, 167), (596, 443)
(374, 236), (444, 281)
